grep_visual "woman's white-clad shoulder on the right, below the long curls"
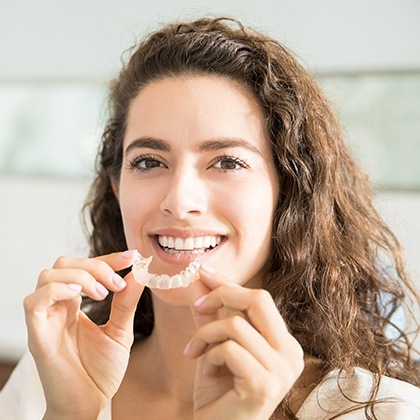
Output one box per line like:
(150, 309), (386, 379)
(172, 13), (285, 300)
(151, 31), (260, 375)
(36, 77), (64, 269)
(297, 368), (420, 420)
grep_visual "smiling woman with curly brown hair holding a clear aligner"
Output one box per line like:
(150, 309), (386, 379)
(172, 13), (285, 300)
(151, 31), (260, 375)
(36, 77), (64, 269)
(2, 15), (420, 419)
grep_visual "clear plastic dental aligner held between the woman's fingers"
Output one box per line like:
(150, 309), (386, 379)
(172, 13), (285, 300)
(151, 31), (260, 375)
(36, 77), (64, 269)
(132, 252), (200, 289)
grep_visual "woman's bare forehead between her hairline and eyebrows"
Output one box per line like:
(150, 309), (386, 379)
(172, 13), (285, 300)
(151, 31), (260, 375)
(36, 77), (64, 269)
(124, 76), (268, 151)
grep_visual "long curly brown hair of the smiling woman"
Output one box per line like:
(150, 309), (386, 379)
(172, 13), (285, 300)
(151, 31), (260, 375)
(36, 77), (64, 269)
(86, 18), (420, 417)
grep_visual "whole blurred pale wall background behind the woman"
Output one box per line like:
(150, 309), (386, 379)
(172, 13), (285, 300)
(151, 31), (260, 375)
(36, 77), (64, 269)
(0, 0), (420, 387)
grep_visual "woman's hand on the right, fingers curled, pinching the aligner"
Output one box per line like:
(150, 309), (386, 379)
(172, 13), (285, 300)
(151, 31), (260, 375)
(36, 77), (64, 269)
(184, 270), (304, 420)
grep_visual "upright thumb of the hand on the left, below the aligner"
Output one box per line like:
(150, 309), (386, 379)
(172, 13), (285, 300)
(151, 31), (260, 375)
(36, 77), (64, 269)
(104, 272), (144, 345)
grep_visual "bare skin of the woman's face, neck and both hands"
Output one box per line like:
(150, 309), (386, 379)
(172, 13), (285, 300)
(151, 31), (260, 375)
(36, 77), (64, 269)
(25, 77), (303, 420)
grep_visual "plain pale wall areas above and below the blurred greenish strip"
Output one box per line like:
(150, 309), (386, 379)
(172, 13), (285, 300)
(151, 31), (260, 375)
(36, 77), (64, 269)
(0, 0), (420, 359)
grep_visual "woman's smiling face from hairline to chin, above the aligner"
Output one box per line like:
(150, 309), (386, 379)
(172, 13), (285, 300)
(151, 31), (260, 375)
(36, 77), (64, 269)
(115, 76), (278, 293)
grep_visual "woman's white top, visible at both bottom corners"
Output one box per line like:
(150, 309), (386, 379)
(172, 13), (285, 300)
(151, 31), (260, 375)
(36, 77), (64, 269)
(0, 352), (420, 420)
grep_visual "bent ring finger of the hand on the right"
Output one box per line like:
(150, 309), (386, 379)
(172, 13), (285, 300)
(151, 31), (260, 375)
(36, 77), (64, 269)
(186, 316), (278, 369)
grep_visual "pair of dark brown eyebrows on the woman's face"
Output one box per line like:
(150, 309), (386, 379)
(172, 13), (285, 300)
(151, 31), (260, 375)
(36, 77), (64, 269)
(125, 137), (263, 157)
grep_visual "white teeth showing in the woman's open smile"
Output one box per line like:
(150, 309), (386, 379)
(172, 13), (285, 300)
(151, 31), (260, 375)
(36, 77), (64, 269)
(157, 235), (224, 254)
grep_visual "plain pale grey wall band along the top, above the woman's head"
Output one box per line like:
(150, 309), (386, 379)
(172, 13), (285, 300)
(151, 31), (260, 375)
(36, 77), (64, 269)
(0, 0), (420, 80)
